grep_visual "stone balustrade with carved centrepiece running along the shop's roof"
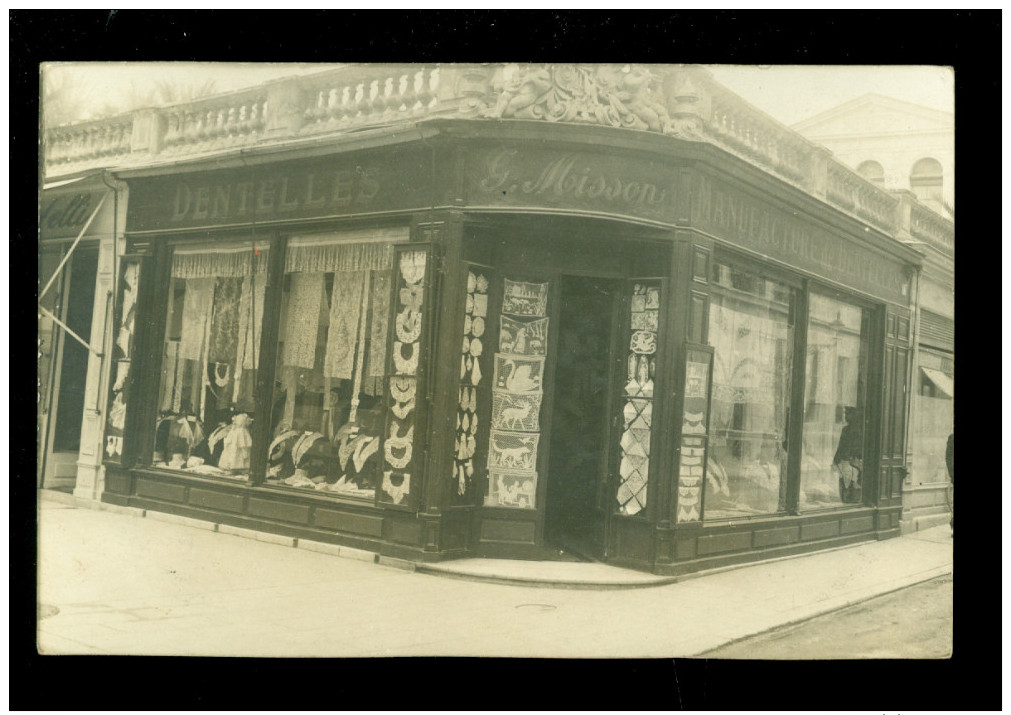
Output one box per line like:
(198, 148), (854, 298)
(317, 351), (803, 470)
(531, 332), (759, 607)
(43, 63), (953, 247)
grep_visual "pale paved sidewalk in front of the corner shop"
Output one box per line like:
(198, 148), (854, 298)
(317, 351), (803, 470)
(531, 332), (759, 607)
(38, 496), (951, 657)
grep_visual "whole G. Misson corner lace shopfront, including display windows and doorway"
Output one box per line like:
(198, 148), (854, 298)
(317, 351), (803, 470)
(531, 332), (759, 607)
(102, 120), (916, 573)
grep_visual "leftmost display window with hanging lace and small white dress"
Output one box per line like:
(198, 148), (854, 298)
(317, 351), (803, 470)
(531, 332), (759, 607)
(151, 243), (267, 479)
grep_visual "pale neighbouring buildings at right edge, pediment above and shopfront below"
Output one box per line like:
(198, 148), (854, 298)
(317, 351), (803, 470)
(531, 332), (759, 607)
(793, 94), (955, 530)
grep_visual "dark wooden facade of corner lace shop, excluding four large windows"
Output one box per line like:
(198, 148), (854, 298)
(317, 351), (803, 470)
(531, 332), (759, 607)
(103, 120), (913, 573)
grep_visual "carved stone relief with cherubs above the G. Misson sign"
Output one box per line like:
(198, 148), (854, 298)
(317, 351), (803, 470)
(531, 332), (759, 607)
(480, 63), (687, 135)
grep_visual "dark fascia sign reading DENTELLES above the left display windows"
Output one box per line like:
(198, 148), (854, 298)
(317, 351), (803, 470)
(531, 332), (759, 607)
(127, 152), (429, 231)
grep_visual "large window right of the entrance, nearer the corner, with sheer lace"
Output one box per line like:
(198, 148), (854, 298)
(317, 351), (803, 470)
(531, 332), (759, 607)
(704, 264), (796, 520)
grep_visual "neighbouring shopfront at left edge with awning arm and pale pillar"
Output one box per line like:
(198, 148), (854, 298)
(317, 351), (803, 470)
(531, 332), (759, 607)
(36, 172), (125, 500)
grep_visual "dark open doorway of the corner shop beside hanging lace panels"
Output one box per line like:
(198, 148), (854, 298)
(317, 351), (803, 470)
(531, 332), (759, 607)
(544, 276), (622, 560)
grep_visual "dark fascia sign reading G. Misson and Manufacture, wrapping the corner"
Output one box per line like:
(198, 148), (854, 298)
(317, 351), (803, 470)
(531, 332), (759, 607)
(468, 148), (908, 302)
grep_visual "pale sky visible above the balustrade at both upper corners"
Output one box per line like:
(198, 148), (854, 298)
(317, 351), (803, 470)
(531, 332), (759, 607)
(41, 63), (954, 124)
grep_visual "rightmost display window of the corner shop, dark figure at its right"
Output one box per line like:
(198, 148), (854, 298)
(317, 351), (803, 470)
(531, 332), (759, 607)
(800, 293), (869, 510)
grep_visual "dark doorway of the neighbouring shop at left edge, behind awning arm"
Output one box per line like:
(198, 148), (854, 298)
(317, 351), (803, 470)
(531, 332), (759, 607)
(41, 247), (98, 489)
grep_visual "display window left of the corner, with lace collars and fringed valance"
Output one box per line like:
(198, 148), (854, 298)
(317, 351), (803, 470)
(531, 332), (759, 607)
(266, 236), (404, 500)
